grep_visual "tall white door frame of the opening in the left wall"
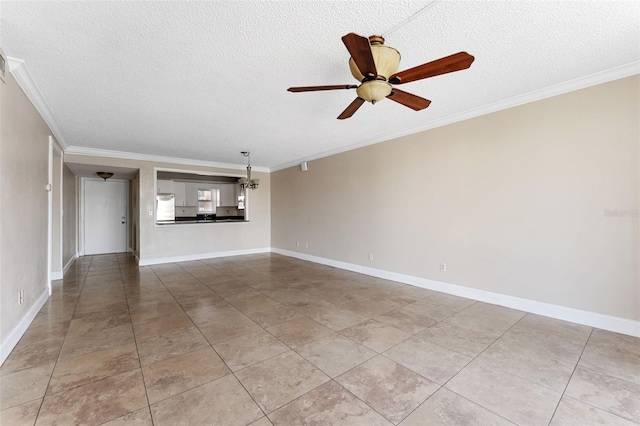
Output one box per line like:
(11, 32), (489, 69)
(46, 135), (64, 295)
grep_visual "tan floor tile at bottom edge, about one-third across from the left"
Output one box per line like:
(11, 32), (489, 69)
(151, 374), (263, 426)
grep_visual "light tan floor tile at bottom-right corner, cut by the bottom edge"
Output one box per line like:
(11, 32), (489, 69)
(550, 396), (637, 426)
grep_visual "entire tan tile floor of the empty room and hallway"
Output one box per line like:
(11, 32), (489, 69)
(0, 254), (640, 426)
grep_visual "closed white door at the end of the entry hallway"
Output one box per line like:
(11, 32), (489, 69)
(84, 179), (129, 255)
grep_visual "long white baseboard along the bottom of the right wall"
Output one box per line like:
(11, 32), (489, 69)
(271, 248), (640, 337)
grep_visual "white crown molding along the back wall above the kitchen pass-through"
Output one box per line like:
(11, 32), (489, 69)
(64, 146), (271, 173)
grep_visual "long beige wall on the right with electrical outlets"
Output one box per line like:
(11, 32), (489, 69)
(271, 76), (640, 320)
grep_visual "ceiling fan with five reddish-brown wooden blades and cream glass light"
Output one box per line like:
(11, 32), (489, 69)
(287, 33), (474, 120)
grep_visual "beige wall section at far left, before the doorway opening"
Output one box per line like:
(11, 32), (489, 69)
(0, 73), (51, 342)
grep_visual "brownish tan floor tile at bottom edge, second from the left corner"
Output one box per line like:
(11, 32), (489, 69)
(37, 369), (147, 425)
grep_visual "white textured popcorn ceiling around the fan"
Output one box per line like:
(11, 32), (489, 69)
(0, 0), (640, 168)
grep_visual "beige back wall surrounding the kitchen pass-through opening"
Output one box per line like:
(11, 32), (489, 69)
(65, 154), (271, 262)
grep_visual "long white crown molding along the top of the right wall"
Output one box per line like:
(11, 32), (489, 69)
(271, 61), (640, 172)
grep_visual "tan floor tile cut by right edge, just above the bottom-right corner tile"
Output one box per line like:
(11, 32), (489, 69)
(565, 366), (640, 423)
